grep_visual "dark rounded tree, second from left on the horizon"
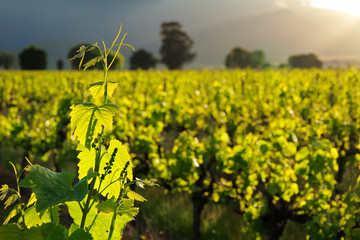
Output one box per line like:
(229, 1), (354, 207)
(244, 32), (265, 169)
(19, 46), (47, 70)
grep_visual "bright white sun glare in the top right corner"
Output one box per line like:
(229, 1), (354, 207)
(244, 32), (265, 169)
(311, 0), (360, 16)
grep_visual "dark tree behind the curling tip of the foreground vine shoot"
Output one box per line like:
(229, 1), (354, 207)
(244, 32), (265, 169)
(68, 43), (125, 70)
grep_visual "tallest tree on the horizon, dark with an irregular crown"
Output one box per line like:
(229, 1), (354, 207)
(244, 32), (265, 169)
(160, 22), (196, 69)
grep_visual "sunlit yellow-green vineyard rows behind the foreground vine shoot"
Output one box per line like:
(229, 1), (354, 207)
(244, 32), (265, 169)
(0, 69), (360, 240)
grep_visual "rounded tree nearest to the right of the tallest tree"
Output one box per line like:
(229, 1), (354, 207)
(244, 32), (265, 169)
(225, 47), (251, 68)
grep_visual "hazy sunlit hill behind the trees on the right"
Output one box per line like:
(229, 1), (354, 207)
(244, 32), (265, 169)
(191, 8), (360, 65)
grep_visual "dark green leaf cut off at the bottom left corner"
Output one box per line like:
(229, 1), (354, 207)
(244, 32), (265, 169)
(0, 224), (43, 240)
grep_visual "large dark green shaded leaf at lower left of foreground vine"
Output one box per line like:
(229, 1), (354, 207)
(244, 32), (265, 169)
(19, 165), (87, 212)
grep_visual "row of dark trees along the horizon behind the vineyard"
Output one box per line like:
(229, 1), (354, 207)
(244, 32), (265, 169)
(0, 21), (322, 70)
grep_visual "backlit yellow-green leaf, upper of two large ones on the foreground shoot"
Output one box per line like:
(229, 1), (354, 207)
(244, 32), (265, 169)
(70, 103), (117, 149)
